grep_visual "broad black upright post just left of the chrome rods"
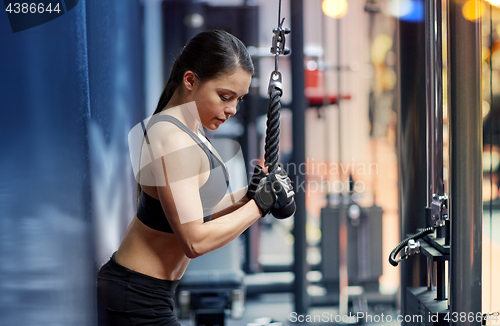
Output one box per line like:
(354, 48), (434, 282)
(396, 16), (427, 324)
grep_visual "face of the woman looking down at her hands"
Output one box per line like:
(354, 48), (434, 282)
(190, 68), (252, 130)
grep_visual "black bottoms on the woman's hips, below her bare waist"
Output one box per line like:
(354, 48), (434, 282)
(97, 254), (181, 326)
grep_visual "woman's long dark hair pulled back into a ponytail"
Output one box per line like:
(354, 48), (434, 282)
(154, 30), (254, 114)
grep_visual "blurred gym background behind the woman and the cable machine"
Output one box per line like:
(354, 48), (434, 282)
(0, 0), (500, 326)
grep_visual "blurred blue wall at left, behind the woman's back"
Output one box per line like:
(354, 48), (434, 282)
(0, 0), (144, 325)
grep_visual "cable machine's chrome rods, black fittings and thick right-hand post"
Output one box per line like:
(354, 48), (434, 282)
(389, 0), (482, 325)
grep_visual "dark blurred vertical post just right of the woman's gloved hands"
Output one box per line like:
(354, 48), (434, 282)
(288, 0), (309, 314)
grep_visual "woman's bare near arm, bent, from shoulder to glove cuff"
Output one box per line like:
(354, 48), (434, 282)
(150, 132), (261, 258)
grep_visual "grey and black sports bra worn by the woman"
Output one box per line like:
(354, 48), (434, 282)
(137, 115), (229, 233)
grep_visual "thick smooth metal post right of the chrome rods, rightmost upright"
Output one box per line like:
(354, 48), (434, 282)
(448, 0), (483, 325)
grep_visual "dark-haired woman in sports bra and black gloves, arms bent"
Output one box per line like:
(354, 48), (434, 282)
(98, 31), (294, 326)
